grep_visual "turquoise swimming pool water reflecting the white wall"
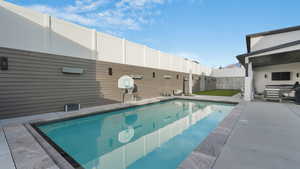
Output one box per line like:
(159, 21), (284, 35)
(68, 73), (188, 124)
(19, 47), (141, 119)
(38, 99), (234, 169)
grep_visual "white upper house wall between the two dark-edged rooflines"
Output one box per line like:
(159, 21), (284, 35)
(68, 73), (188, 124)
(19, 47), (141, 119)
(251, 30), (300, 52)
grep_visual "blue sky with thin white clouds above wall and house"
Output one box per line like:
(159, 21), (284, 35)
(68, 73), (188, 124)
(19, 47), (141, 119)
(6, 0), (300, 67)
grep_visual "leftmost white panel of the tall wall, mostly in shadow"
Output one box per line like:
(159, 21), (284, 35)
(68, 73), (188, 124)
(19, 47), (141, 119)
(0, 1), (45, 52)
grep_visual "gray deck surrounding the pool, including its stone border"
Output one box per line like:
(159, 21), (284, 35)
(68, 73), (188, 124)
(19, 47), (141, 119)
(0, 96), (300, 169)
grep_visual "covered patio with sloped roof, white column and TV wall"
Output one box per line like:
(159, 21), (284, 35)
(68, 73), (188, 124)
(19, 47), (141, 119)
(237, 41), (300, 101)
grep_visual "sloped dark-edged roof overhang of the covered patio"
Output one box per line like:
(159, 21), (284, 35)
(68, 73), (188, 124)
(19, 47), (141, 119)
(237, 41), (300, 68)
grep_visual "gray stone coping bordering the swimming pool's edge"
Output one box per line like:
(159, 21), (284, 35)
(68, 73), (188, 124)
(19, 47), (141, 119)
(24, 96), (241, 169)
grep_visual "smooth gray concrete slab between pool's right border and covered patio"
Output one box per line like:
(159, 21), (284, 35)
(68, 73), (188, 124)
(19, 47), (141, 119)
(213, 102), (300, 169)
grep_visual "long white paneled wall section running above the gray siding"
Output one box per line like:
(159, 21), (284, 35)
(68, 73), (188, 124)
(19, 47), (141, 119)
(0, 1), (210, 75)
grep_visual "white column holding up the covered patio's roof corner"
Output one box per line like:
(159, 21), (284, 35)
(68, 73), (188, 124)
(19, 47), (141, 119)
(244, 58), (254, 101)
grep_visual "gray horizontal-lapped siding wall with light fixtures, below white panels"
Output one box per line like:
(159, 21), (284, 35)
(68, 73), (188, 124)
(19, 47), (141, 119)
(0, 48), (186, 118)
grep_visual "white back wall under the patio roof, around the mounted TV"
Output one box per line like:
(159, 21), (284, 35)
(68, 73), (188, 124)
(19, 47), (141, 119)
(253, 62), (300, 93)
